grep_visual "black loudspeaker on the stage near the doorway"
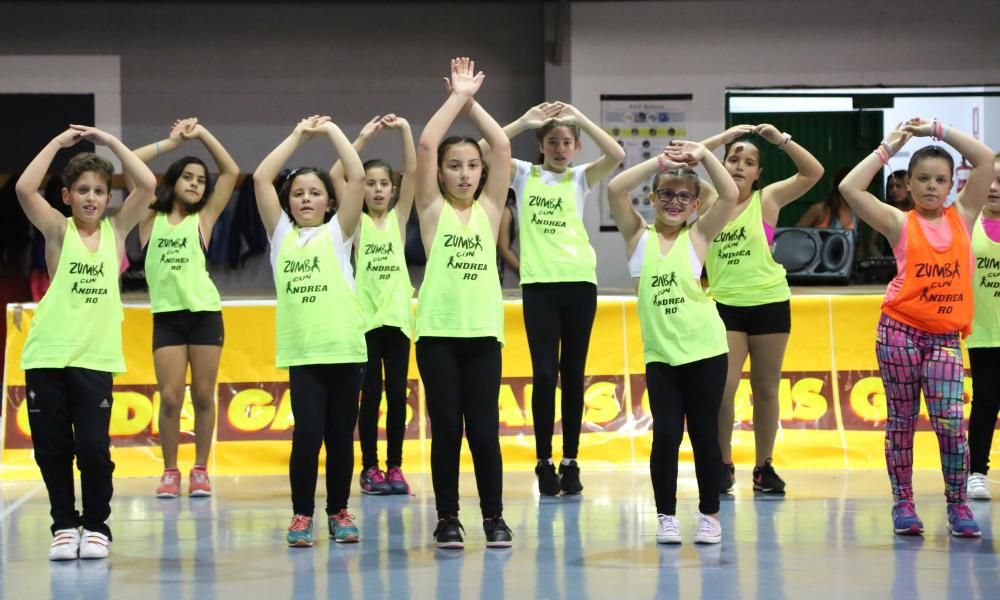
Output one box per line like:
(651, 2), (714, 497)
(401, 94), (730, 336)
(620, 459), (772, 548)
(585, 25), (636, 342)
(772, 227), (854, 284)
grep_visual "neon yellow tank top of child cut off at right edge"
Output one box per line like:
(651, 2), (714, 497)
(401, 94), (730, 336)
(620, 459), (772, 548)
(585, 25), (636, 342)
(966, 215), (1000, 348)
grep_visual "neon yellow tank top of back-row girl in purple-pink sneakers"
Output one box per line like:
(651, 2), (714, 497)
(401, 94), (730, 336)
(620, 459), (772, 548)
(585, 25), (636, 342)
(355, 209), (413, 337)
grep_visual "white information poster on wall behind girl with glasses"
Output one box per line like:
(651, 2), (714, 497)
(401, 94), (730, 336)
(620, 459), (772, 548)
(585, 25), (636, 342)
(600, 94), (692, 231)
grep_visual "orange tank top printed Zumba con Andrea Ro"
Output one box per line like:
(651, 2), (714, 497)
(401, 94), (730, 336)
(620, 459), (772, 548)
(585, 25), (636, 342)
(882, 206), (973, 336)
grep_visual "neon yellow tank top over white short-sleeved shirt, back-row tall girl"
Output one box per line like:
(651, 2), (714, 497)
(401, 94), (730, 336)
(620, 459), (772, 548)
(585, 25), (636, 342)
(518, 165), (597, 285)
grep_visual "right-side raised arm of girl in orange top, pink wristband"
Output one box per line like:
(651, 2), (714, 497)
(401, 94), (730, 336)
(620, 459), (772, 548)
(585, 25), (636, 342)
(903, 118), (994, 231)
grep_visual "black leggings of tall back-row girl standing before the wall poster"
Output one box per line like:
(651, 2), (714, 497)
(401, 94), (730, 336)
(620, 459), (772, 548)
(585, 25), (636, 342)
(521, 281), (597, 460)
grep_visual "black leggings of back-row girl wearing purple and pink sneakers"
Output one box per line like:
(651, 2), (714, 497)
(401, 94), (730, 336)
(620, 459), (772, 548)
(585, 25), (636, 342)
(358, 325), (410, 470)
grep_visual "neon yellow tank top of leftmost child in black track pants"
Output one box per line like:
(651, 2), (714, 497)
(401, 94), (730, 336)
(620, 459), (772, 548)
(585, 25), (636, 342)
(21, 217), (125, 373)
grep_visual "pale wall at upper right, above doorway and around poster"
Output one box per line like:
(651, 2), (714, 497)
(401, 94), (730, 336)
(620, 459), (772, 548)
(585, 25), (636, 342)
(571, 0), (1000, 288)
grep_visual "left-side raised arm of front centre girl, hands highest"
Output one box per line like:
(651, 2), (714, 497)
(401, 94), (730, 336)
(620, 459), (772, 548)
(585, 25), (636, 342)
(414, 57), (480, 216)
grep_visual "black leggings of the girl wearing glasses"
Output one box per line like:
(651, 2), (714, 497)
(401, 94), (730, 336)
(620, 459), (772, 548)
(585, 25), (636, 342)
(646, 354), (729, 515)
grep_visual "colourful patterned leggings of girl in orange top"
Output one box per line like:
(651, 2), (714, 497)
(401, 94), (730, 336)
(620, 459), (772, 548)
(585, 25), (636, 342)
(875, 314), (969, 503)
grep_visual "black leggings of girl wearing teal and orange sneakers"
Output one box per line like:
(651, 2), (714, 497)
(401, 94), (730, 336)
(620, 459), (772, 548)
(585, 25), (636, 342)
(288, 363), (365, 516)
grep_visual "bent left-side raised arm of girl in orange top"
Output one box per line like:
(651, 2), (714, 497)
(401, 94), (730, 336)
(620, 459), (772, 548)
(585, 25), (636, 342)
(838, 128), (910, 247)
